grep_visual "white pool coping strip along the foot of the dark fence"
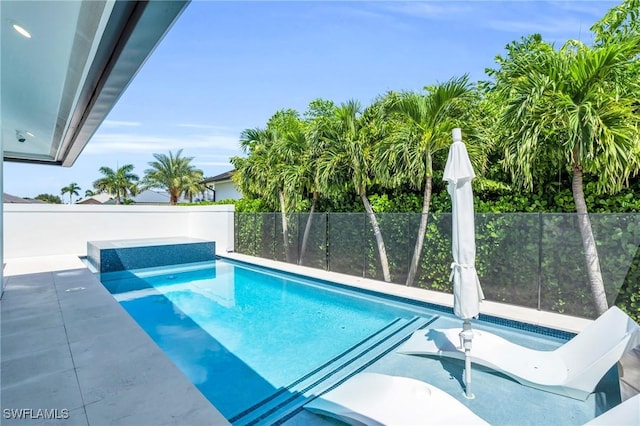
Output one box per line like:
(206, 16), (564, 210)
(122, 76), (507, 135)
(218, 252), (593, 334)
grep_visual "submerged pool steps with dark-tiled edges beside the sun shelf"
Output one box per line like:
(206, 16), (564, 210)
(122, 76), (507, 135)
(229, 316), (437, 426)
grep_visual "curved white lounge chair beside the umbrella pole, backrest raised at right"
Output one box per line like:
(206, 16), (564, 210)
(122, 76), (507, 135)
(397, 306), (640, 400)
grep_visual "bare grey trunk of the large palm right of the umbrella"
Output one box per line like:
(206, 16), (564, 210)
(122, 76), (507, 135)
(571, 158), (609, 315)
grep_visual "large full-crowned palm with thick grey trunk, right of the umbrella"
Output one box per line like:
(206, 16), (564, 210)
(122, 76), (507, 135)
(494, 36), (640, 314)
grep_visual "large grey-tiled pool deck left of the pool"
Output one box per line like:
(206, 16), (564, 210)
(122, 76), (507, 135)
(0, 256), (228, 426)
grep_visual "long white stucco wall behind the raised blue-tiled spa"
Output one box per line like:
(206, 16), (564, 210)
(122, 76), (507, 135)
(2, 204), (233, 259)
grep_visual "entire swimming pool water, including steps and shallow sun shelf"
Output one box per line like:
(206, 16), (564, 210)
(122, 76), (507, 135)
(101, 255), (619, 425)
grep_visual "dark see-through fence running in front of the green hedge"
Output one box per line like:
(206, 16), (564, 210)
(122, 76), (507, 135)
(235, 213), (640, 318)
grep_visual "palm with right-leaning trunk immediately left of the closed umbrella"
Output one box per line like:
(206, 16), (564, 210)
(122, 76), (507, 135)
(376, 76), (470, 286)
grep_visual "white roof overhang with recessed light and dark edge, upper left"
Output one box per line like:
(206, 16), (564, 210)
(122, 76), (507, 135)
(0, 0), (189, 166)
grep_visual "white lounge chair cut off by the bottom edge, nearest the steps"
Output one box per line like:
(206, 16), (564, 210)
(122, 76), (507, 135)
(305, 373), (488, 426)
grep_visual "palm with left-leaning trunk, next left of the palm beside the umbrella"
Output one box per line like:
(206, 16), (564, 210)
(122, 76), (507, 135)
(318, 100), (391, 282)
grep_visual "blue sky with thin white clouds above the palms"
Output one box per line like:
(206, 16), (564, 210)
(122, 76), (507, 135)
(4, 0), (619, 197)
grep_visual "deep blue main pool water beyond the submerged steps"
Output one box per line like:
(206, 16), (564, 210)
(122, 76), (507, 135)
(101, 259), (435, 419)
